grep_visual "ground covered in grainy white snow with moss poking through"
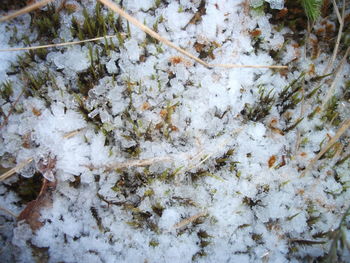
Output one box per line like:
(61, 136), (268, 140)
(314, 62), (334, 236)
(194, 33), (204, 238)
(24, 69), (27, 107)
(0, 0), (350, 262)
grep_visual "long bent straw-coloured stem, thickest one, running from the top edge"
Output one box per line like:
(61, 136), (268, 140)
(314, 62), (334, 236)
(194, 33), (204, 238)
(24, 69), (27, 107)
(98, 0), (288, 69)
